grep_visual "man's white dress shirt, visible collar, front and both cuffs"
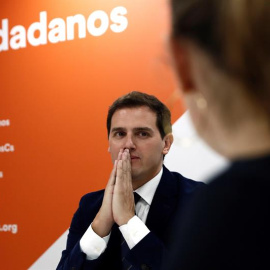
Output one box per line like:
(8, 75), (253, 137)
(80, 168), (163, 260)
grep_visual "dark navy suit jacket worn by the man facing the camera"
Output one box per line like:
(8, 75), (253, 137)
(57, 167), (204, 270)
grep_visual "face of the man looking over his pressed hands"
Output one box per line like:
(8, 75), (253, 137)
(109, 106), (170, 189)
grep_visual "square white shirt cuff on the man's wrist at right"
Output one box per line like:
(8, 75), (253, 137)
(119, 216), (150, 249)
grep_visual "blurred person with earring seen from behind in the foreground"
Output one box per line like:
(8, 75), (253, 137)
(167, 0), (270, 270)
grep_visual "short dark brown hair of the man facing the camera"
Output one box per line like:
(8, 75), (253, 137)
(107, 91), (172, 139)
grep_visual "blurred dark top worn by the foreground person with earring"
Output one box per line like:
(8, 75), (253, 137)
(166, 155), (270, 270)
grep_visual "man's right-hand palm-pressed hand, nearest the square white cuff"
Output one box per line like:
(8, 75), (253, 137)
(112, 149), (135, 226)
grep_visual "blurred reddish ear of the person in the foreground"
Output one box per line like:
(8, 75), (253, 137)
(170, 38), (194, 93)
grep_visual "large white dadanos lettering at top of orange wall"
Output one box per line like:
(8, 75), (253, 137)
(0, 6), (128, 52)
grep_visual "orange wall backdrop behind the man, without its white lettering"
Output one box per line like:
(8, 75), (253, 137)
(0, 0), (183, 270)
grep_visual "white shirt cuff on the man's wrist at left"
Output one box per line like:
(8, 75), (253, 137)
(80, 224), (110, 260)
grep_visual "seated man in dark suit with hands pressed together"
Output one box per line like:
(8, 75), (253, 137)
(57, 92), (205, 270)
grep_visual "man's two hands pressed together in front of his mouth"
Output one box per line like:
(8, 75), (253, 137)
(92, 149), (135, 237)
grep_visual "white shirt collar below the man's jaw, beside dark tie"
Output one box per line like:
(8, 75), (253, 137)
(135, 167), (163, 205)
